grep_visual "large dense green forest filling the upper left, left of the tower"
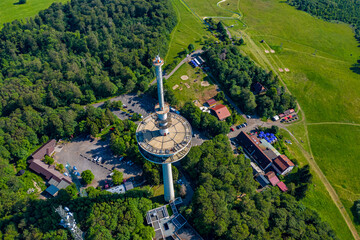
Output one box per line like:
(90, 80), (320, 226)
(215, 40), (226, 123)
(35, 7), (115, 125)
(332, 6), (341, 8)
(0, 0), (176, 164)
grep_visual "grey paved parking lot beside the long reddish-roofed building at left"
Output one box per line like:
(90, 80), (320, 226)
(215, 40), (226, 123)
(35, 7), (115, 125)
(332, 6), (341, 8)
(54, 138), (142, 187)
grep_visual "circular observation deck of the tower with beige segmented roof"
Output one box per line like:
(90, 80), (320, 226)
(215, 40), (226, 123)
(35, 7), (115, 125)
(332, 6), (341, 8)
(136, 113), (192, 164)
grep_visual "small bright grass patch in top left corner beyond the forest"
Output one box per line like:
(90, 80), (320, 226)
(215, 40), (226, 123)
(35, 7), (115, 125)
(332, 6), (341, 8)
(0, 0), (68, 29)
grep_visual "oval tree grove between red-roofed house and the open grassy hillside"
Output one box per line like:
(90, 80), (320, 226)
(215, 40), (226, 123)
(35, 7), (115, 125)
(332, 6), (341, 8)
(203, 44), (296, 118)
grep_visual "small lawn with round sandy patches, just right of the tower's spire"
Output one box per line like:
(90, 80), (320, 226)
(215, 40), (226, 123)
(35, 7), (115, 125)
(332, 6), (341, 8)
(165, 63), (217, 107)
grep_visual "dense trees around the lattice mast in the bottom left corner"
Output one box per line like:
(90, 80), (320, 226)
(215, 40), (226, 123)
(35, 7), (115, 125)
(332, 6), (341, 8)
(0, 189), (155, 240)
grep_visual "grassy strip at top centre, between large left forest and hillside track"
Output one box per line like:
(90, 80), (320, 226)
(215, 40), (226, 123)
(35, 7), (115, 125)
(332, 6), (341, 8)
(165, 0), (210, 64)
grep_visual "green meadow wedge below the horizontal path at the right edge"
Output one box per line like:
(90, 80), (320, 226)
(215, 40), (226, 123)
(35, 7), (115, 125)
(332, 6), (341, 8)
(308, 125), (360, 231)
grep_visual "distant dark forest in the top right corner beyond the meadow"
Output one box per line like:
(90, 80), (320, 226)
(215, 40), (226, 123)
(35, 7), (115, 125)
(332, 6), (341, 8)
(287, 0), (360, 40)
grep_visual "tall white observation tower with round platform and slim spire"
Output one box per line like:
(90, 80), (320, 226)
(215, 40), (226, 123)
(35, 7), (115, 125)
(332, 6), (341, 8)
(136, 56), (192, 202)
